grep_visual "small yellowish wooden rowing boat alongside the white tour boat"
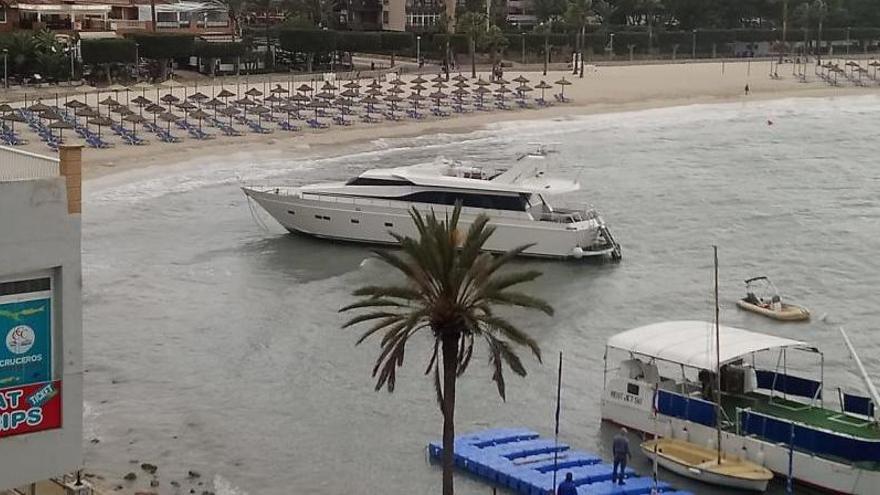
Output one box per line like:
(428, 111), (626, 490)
(641, 438), (773, 492)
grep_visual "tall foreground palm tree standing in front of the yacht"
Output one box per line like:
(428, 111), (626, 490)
(340, 205), (553, 495)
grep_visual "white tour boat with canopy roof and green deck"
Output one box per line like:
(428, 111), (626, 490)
(602, 321), (880, 495)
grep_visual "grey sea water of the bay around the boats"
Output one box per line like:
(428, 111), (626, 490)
(83, 96), (880, 495)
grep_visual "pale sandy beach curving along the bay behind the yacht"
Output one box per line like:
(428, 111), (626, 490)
(5, 61), (880, 178)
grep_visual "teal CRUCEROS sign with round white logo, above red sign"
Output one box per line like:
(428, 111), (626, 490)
(0, 298), (52, 387)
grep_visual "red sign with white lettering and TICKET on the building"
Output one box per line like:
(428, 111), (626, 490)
(0, 380), (61, 438)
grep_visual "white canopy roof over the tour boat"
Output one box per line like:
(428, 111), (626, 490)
(606, 321), (819, 370)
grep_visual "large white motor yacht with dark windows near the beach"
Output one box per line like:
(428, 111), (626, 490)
(242, 149), (621, 260)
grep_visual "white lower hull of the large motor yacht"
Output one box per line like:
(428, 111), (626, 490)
(243, 188), (620, 258)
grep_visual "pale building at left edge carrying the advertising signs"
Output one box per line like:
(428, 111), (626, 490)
(0, 147), (83, 493)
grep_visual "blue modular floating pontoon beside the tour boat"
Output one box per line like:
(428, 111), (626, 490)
(428, 428), (691, 495)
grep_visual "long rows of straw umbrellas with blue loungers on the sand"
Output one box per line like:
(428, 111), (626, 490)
(0, 74), (571, 145)
